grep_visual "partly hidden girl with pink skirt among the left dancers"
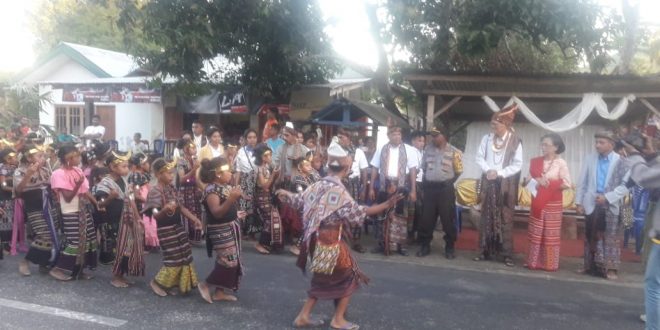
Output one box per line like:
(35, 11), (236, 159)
(128, 154), (158, 249)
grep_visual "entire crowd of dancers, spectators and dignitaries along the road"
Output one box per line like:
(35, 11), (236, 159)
(0, 105), (660, 329)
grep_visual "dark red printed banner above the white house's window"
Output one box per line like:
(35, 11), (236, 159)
(62, 85), (161, 103)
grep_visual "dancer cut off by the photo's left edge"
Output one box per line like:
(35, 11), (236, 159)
(0, 147), (18, 255)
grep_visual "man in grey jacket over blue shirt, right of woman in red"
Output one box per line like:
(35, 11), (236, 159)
(575, 131), (628, 279)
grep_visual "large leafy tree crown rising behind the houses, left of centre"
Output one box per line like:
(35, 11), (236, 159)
(119, 0), (338, 101)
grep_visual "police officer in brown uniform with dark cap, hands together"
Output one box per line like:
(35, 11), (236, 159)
(417, 128), (463, 259)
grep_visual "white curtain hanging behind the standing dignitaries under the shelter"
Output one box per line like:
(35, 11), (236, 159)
(461, 122), (603, 182)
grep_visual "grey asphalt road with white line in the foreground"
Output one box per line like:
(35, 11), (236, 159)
(0, 245), (643, 330)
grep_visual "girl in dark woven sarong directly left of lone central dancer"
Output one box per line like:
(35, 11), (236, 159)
(254, 144), (284, 254)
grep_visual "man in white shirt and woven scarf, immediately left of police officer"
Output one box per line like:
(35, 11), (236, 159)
(369, 125), (418, 256)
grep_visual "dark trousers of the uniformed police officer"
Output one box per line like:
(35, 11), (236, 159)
(417, 181), (456, 249)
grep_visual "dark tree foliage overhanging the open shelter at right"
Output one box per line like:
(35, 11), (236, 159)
(382, 0), (621, 72)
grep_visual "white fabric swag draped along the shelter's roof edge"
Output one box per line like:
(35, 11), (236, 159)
(482, 93), (635, 133)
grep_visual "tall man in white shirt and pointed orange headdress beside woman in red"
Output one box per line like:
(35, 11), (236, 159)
(474, 104), (523, 267)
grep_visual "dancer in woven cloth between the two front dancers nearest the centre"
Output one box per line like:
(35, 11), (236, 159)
(176, 141), (202, 244)
